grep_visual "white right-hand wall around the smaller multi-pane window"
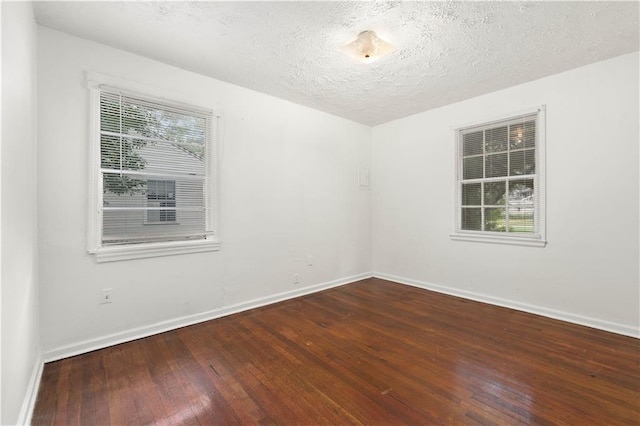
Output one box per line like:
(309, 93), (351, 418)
(373, 53), (640, 335)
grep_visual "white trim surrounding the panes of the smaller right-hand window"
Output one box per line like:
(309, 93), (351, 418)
(449, 105), (547, 247)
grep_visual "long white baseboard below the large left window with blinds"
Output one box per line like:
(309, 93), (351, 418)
(42, 272), (373, 362)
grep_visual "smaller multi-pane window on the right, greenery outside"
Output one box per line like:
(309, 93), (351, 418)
(451, 107), (546, 246)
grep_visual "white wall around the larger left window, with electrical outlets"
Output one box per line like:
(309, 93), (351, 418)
(38, 27), (372, 354)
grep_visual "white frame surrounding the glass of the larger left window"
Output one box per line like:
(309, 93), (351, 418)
(86, 71), (221, 263)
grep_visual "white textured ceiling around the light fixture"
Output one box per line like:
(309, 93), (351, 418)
(34, 1), (639, 125)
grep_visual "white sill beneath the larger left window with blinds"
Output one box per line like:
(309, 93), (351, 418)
(91, 240), (220, 263)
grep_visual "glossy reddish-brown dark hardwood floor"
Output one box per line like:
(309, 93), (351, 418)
(33, 279), (640, 425)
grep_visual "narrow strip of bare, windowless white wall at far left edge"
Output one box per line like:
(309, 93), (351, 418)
(0, 2), (39, 424)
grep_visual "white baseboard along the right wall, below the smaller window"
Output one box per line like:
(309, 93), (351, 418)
(373, 272), (640, 338)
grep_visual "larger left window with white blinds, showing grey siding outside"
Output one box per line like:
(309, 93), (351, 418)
(89, 76), (219, 261)
